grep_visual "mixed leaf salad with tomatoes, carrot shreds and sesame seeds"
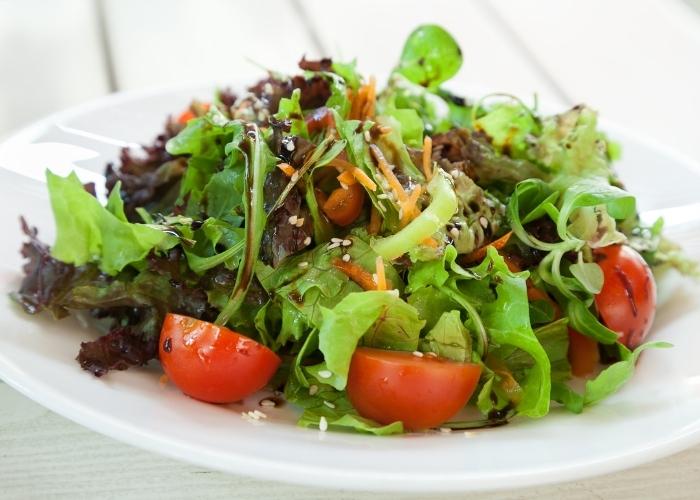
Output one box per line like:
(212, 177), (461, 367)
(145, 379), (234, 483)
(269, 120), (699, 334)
(13, 25), (696, 435)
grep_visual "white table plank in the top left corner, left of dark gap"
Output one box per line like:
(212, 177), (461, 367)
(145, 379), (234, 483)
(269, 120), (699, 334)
(0, 0), (109, 135)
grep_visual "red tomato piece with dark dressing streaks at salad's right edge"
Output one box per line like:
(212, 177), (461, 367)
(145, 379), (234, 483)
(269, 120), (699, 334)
(595, 245), (656, 349)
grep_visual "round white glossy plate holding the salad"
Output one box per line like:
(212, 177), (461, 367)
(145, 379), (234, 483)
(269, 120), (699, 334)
(0, 83), (700, 492)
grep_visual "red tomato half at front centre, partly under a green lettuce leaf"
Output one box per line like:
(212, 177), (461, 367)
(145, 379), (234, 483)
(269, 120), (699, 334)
(347, 347), (481, 430)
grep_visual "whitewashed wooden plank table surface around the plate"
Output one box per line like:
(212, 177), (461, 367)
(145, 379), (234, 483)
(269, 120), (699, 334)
(0, 0), (700, 499)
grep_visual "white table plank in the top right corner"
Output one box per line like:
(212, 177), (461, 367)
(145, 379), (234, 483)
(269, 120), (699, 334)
(493, 0), (700, 164)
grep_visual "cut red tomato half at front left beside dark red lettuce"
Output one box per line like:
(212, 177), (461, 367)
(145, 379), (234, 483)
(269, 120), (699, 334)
(159, 314), (281, 403)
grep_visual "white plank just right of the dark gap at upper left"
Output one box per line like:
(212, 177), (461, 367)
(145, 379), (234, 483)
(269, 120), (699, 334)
(104, 0), (316, 89)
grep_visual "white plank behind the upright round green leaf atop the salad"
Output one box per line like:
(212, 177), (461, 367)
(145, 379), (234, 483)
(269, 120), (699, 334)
(303, 0), (564, 104)
